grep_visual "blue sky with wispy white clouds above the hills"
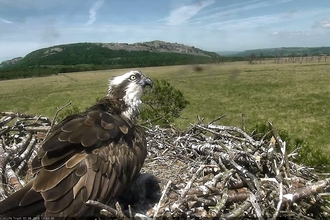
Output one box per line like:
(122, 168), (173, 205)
(0, 0), (330, 62)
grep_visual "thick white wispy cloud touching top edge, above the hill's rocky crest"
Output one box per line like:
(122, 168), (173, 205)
(167, 0), (215, 25)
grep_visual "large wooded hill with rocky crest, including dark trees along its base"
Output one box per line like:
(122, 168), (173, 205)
(0, 41), (220, 80)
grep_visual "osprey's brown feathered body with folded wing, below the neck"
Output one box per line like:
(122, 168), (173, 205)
(20, 110), (146, 216)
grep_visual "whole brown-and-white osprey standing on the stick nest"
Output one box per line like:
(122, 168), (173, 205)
(0, 71), (152, 217)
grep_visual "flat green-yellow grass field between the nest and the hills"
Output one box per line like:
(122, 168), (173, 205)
(0, 63), (330, 153)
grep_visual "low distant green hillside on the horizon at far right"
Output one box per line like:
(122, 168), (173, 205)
(230, 47), (330, 57)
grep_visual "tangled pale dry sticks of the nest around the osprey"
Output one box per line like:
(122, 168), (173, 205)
(0, 112), (330, 219)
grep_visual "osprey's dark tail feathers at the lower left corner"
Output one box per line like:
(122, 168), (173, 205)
(0, 181), (45, 217)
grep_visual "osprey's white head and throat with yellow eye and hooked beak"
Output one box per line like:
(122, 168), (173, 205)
(108, 70), (152, 121)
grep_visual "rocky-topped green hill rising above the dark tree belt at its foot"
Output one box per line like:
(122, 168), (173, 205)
(1, 41), (218, 66)
